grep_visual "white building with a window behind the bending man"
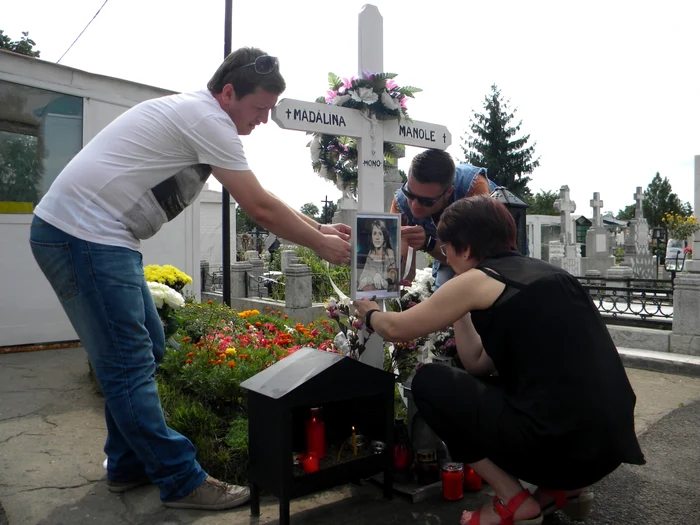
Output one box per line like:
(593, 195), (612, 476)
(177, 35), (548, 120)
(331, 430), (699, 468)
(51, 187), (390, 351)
(0, 51), (202, 347)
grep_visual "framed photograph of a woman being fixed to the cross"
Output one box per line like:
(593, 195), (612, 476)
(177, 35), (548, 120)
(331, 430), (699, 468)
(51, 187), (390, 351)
(350, 212), (401, 300)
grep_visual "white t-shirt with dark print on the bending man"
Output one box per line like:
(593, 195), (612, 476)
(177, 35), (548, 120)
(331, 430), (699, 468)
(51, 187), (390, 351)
(34, 91), (249, 250)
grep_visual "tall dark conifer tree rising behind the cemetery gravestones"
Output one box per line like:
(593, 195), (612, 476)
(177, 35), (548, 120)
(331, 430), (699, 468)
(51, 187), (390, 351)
(461, 84), (540, 197)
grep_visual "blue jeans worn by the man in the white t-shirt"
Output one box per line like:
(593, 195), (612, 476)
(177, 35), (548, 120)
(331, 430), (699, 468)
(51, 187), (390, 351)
(30, 216), (207, 501)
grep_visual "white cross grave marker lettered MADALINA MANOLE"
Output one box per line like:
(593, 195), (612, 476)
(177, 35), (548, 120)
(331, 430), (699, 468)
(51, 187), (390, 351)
(272, 4), (452, 368)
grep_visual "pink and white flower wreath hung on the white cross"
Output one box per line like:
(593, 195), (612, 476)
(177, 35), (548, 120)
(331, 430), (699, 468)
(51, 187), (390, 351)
(308, 73), (423, 195)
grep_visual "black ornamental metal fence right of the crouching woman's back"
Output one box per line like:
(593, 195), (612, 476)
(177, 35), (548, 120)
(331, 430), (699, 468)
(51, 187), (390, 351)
(577, 277), (673, 330)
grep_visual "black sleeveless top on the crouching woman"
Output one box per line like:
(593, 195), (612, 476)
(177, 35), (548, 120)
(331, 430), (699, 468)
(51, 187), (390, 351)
(472, 252), (644, 476)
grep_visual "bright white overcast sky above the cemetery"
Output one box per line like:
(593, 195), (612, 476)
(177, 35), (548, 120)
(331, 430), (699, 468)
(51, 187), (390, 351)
(0, 0), (700, 216)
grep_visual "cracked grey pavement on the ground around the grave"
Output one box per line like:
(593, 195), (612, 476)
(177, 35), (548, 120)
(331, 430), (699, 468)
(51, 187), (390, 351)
(0, 348), (700, 525)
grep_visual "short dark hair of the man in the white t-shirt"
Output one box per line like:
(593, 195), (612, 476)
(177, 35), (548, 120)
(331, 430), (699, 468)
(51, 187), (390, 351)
(207, 47), (287, 100)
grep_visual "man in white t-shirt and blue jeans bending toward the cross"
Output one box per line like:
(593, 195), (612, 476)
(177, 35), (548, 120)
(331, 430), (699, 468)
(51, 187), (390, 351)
(30, 48), (350, 510)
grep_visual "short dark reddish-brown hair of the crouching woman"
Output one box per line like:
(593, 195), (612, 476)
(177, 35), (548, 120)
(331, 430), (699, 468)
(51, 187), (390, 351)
(437, 195), (517, 262)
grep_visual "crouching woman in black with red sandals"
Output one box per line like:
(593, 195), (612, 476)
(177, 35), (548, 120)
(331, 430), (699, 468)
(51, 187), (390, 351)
(355, 196), (644, 525)
